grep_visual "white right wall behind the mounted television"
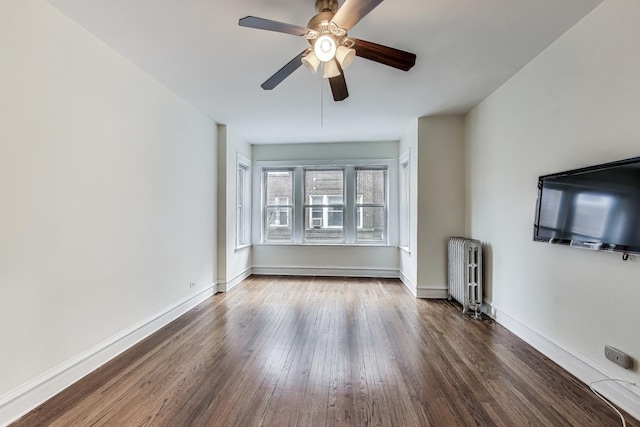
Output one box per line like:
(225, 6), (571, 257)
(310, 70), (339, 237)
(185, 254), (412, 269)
(466, 0), (640, 416)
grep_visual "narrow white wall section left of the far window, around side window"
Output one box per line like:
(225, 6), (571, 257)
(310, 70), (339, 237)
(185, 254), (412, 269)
(218, 125), (251, 291)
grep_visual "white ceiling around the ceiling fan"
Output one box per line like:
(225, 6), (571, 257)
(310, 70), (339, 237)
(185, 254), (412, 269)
(49, 0), (603, 143)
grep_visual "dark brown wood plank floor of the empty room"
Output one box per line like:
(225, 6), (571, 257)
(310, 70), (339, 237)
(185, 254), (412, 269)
(15, 277), (640, 427)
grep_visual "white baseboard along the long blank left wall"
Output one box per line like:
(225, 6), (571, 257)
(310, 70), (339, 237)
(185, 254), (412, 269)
(0, 285), (217, 426)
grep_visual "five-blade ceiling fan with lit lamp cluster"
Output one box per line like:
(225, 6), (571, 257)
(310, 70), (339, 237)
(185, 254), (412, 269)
(238, 0), (416, 101)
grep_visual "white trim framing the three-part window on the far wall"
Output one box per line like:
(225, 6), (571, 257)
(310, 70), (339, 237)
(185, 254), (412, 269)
(252, 158), (399, 247)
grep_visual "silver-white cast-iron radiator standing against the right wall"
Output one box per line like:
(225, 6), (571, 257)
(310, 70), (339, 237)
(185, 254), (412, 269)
(449, 237), (482, 318)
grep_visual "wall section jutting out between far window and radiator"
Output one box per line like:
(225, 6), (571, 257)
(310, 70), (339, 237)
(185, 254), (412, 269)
(399, 115), (465, 298)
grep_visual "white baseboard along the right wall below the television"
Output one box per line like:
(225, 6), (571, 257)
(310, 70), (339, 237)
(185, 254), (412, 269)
(485, 302), (640, 420)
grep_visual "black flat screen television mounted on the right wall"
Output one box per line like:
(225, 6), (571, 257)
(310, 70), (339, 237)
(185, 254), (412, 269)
(533, 157), (640, 254)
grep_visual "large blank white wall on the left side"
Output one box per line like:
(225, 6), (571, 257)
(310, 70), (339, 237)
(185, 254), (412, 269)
(0, 0), (216, 424)
